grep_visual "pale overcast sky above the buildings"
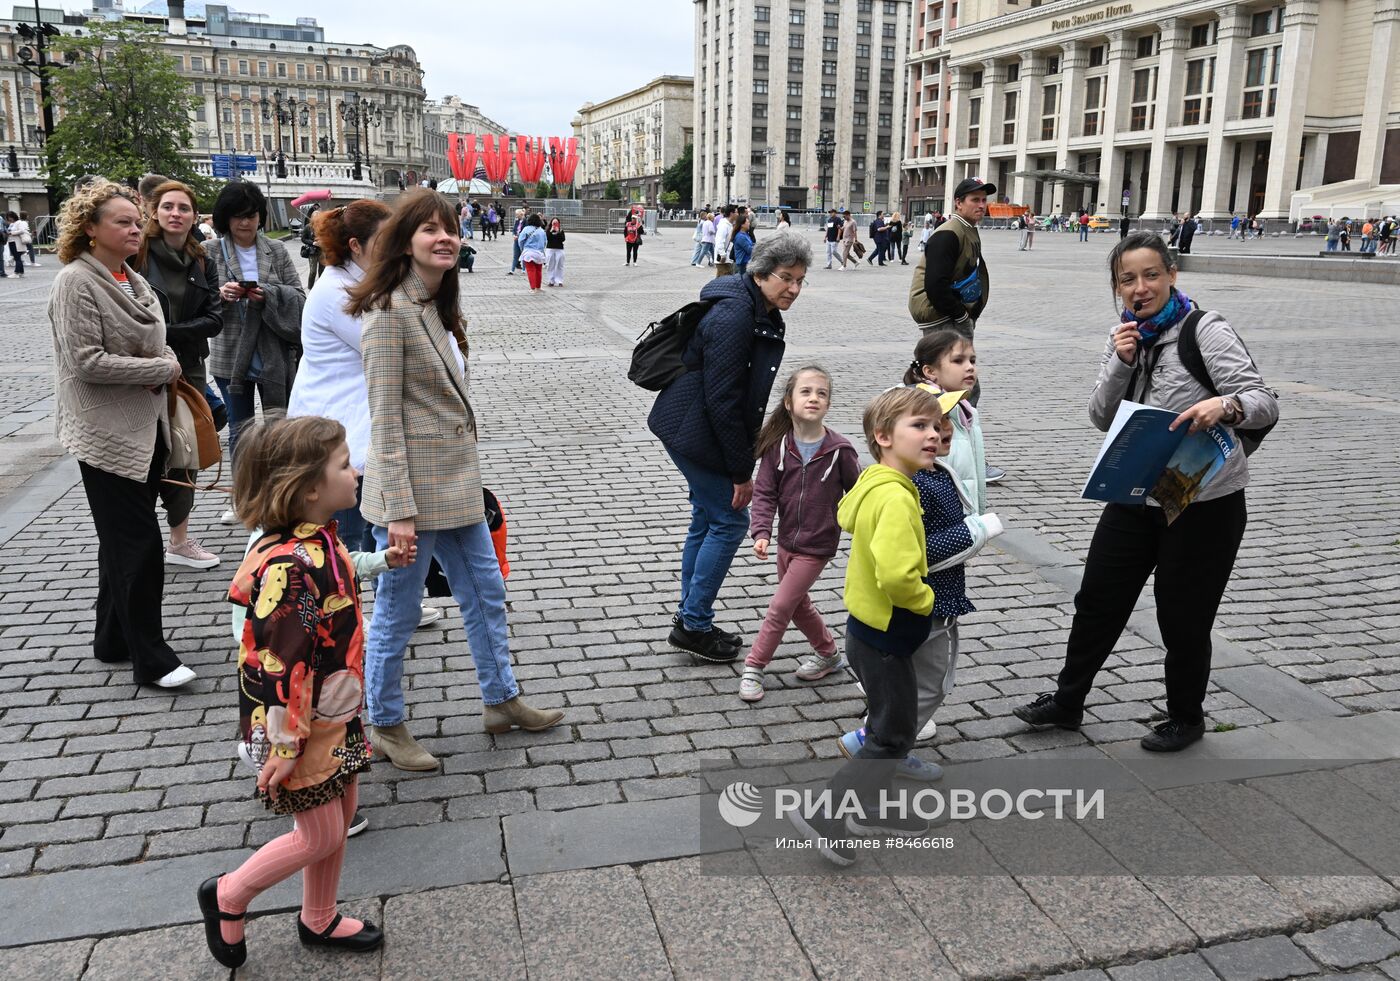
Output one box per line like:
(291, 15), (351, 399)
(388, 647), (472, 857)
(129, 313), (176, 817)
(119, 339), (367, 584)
(88, 0), (694, 136)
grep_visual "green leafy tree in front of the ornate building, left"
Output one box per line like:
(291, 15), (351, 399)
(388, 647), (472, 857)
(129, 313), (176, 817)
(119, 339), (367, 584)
(43, 21), (216, 197)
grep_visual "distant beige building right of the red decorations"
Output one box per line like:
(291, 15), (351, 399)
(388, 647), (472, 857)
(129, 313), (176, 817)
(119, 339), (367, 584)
(574, 76), (694, 206)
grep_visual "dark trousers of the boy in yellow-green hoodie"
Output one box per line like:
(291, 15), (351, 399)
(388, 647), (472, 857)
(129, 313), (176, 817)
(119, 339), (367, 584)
(832, 630), (918, 816)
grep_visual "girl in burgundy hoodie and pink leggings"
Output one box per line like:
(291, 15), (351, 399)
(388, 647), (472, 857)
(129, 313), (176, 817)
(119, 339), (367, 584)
(739, 365), (861, 701)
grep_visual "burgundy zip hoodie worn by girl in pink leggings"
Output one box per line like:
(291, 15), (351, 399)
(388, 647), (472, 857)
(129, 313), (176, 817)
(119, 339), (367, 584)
(749, 430), (861, 558)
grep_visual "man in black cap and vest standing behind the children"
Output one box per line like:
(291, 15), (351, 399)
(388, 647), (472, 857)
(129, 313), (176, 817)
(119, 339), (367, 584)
(909, 178), (1007, 484)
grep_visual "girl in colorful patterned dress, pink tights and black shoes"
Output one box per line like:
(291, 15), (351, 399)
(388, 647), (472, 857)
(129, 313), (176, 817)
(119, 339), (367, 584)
(199, 416), (413, 967)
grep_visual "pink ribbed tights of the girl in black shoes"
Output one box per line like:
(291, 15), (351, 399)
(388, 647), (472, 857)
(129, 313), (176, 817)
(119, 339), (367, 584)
(218, 778), (360, 933)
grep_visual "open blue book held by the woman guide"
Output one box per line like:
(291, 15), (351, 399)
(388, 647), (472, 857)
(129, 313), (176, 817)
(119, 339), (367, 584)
(1082, 400), (1236, 523)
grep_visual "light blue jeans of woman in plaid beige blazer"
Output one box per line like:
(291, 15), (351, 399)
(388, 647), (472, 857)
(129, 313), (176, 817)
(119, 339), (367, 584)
(364, 521), (519, 726)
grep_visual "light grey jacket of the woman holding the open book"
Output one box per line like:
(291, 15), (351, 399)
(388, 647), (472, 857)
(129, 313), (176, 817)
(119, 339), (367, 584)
(1089, 312), (1278, 501)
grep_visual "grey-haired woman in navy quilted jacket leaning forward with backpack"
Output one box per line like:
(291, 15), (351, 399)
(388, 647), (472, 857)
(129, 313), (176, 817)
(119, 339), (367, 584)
(647, 235), (812, 663)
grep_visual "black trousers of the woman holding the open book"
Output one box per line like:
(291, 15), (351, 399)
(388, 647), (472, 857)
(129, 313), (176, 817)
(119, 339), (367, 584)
(1054, 490), (1249, 725)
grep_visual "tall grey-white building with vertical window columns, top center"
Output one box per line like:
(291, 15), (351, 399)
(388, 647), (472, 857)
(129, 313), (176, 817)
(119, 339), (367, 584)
(694, 0), (913, 211)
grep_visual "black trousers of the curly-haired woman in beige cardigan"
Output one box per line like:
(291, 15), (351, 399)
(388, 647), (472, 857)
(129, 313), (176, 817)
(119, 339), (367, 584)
(78, 437), (181, 684)
